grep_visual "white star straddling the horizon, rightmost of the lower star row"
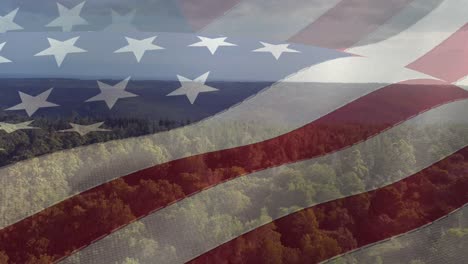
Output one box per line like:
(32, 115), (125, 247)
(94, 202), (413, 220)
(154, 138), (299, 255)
(167, 72), (218, 104)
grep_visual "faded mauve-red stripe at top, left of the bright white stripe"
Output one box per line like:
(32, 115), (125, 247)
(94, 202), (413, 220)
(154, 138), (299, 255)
(290, 0), (412, 50)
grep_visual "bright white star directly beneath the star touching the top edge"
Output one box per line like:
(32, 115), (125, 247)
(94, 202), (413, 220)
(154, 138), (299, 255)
(34, 37), (86, 67)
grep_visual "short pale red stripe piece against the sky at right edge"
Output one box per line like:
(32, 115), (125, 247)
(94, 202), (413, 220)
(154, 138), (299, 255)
(408, 24), (468, 82)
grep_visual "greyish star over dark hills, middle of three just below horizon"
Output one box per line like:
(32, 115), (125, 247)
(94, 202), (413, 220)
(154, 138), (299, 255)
(86, 77), (138, 109)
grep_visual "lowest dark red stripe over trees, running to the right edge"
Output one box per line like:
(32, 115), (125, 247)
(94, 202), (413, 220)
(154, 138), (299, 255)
(190, 148), (468, 264)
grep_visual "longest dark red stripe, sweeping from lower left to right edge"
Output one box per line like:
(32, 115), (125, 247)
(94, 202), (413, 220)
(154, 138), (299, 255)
(0, 81), (468, 263)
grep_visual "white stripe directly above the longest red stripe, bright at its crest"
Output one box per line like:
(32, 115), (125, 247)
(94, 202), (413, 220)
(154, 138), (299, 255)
(0, 57), (427, 227)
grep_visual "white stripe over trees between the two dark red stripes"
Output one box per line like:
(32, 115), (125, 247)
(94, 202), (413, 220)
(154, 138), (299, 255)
(64, 100), (468, 263)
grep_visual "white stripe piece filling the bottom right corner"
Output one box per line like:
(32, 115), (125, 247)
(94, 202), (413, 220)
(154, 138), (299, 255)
(324, 205), (468, 264)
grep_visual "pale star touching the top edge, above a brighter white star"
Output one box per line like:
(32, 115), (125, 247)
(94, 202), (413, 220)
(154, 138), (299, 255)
(46, 1), (88, 32)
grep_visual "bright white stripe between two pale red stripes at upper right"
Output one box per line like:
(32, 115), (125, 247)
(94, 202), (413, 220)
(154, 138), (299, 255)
(347, 0), (468, 67)
